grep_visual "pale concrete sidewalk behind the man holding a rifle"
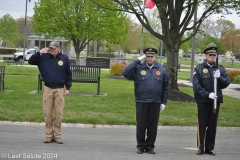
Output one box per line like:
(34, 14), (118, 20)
(178, 80), (240, 99)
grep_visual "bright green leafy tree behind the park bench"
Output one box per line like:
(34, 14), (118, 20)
(33, 0), (128, 60)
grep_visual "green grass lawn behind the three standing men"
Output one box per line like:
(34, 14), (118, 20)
(0, 65), (240, 126)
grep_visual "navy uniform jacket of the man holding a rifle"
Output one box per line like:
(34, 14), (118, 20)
(193, 60), (230, 103)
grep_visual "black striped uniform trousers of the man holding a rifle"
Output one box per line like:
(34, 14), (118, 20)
(197, 102), (220, 151)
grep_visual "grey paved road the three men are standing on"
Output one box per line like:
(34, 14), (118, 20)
(0, 125), (240, 160)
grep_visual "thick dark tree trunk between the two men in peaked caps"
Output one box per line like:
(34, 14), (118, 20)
(166, 44), (179, 90)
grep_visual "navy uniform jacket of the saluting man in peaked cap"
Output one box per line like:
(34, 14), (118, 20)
(122, 59), (169, 104)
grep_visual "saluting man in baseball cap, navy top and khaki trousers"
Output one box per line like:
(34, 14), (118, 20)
(28, 41), (72, 144)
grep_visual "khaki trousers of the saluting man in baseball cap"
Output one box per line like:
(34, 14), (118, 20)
(43, 86), (64, 138)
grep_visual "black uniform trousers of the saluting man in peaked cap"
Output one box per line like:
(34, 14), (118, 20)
(136, 102), (160, 149)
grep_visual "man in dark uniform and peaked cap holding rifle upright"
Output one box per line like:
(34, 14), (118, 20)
(193, 47), (230, 155)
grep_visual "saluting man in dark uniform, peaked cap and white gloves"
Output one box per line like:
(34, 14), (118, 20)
(122, 48), (169, 154)
